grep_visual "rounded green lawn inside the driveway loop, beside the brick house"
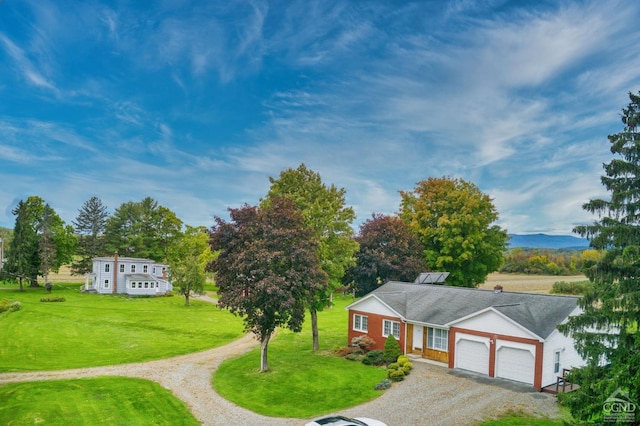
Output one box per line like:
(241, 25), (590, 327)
(213, 298), (386, 418)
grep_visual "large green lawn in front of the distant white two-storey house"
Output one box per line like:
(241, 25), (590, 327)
(0, 285), (244, 372)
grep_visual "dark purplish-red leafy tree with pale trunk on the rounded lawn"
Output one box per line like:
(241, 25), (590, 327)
(211, 198), (327, 372)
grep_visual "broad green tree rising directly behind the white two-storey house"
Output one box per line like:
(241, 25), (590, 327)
(105, 197), (182, 262)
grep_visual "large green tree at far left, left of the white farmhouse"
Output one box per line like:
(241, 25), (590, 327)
(7, 196), (76, 289)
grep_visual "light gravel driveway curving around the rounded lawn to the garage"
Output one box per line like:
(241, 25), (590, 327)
(0, 294), (559, 426)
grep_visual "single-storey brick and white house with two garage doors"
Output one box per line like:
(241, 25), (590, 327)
(346, 273), (585, 390)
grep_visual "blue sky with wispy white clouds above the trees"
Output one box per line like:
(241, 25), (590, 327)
(0, 0), (640, 234)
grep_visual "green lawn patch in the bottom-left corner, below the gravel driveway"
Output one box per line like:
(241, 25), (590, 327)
(0, 377), (200, 426)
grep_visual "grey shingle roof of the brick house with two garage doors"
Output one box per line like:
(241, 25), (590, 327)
(352, 281), (579, 338)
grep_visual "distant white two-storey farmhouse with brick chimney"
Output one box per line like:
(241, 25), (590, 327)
(83, 253), (173, 296)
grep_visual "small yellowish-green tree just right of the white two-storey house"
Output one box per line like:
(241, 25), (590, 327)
(168, 226), (214, 306)
